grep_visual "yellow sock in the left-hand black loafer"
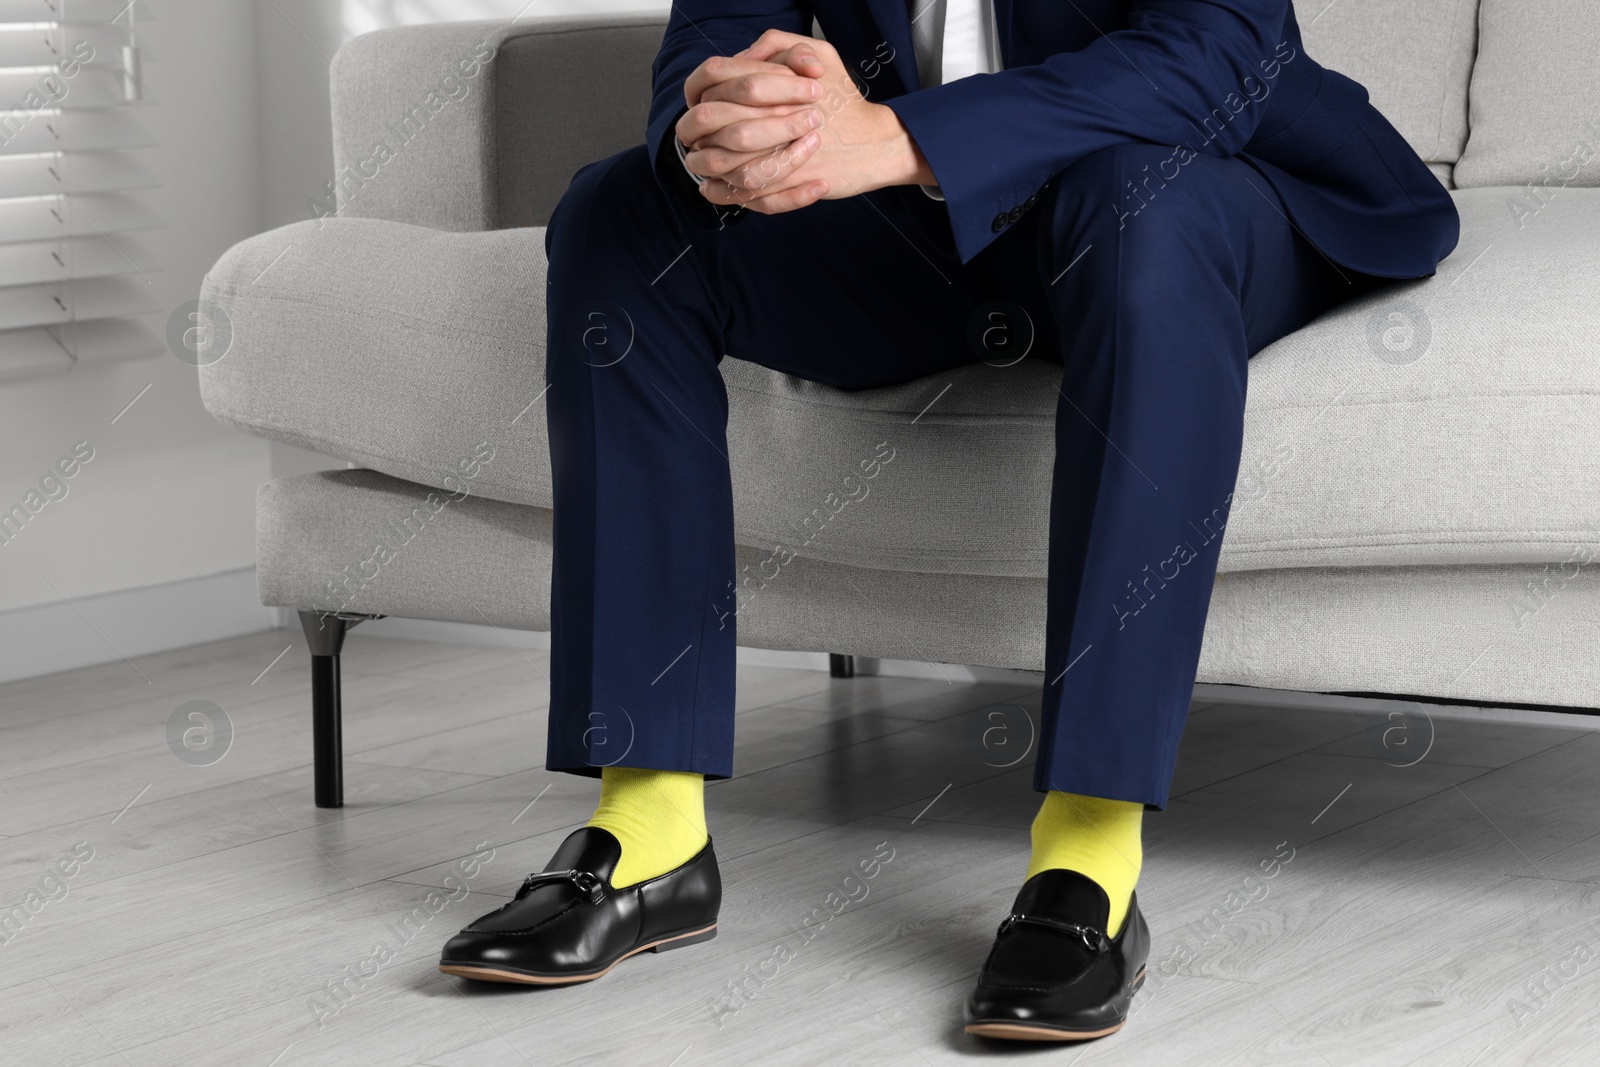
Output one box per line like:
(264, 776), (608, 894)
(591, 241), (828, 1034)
(589, 766), (707, 889)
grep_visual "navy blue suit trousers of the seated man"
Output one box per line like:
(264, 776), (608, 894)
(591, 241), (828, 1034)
(546, 144), (1376, 808)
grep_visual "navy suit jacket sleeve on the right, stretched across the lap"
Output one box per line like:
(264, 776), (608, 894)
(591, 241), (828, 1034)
(883, 0), (1309, 262)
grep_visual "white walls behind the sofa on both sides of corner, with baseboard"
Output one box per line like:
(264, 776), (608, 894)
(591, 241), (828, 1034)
(0, 0), (667, 680)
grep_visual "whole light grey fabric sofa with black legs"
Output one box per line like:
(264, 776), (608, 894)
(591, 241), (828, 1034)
(200, 0), (1600, 805)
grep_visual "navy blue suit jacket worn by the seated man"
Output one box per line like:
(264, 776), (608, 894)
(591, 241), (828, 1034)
(648, 0), (1459, 278)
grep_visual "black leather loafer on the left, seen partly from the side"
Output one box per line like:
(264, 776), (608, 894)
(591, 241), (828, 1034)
(438, 825), (722, 985)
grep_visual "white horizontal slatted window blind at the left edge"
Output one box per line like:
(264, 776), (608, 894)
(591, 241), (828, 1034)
(0, 0), (163, 381)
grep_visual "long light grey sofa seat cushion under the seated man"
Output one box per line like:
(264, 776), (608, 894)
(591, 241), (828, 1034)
(200, 189), (1600, 577)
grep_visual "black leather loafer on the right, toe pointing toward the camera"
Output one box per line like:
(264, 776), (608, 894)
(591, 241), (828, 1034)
(965, 870), (1150, 1041)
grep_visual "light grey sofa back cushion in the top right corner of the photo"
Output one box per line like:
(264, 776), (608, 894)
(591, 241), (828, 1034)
(1456, 0), (1600, 189)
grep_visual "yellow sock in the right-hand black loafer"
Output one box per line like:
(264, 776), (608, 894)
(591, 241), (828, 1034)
(1027, 790), (1144, 937)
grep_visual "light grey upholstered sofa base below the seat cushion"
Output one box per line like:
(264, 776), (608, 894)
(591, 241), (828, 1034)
(258, 470), (1600, 707)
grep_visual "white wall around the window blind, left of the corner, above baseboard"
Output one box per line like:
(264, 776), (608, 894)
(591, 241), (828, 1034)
(0, 0), (267, 617)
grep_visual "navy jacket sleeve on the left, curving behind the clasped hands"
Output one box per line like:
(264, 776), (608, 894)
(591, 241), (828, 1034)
(645, 0), (813, 230)
